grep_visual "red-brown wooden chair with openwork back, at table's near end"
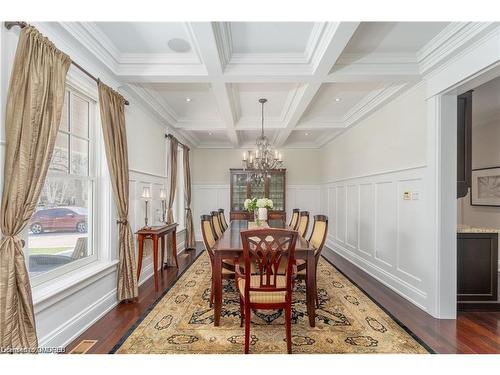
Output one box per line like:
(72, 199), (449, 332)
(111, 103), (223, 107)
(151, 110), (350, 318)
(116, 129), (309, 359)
(235, 228), (298, 354)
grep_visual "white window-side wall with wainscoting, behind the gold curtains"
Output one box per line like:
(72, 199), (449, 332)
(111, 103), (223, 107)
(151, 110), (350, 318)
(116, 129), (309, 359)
(0, 24), (184, 347)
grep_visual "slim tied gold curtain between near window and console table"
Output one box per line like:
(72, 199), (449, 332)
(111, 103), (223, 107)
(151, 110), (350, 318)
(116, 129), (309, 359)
(98, 81), (139, 301)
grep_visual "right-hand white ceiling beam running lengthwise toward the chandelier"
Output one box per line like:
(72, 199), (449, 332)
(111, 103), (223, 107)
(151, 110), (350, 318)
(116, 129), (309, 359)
(276, 22), (359, 147)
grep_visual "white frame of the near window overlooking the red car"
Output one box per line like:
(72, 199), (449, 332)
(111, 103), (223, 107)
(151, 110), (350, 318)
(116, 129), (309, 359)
(25, 79), (103, 288)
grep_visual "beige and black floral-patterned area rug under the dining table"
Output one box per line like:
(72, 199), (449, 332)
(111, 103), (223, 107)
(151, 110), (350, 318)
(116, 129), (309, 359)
(112, 253), (428, 354)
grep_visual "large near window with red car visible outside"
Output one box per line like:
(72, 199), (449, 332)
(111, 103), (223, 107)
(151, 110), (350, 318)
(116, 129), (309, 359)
(28, 88), (97, 284)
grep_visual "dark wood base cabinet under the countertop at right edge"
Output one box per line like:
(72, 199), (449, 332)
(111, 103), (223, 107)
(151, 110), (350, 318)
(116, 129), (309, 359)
(457, 233), (498, 308)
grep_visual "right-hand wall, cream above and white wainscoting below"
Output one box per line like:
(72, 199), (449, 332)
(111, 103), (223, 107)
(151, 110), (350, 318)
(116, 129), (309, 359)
(321, 84), (432, 311)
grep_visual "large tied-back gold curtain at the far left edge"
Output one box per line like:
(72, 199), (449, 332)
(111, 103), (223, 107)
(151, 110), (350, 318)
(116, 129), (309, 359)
(0, 26), (71, 352)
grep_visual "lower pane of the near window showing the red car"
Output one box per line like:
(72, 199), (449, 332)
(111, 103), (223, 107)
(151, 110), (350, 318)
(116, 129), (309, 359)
(28, 176), (93, 276)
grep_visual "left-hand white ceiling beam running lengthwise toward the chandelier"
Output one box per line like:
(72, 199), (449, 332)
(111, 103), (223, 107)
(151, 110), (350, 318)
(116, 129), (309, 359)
(188, 22), (239, 147)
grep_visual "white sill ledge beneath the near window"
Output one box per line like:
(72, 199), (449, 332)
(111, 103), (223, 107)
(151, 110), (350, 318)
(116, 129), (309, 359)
(33, 260), (118, 313)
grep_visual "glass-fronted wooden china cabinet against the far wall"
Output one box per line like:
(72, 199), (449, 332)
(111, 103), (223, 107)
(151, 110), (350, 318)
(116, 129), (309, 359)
(230, 168), (286, 220)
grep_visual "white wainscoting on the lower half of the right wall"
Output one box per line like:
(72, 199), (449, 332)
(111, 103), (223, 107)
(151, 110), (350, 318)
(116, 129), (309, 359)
(321, 167), (431, 310)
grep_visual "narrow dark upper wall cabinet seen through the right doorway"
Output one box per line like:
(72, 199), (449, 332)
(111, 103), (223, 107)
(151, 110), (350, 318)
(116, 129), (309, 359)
(457, 90), (472, 198)
